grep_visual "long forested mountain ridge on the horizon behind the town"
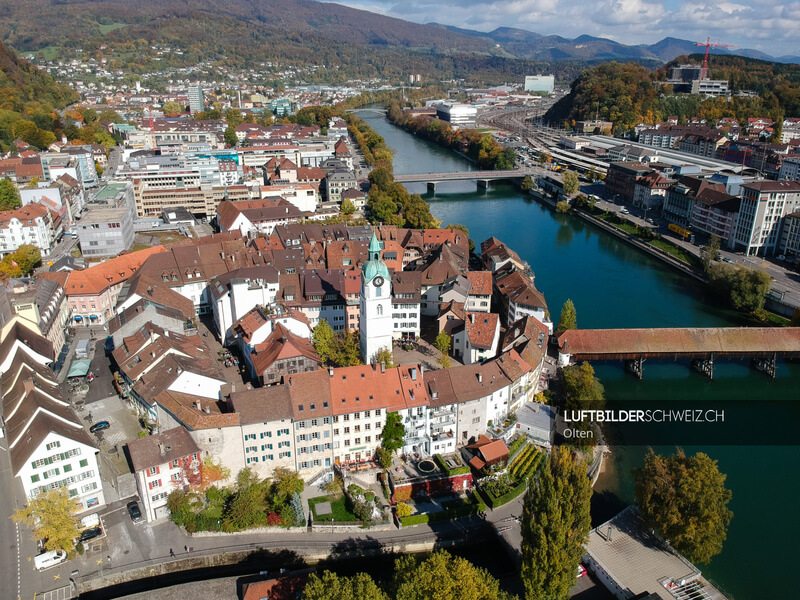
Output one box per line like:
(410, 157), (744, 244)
(0, 0), (792, 83)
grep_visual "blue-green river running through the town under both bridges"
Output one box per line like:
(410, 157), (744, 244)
(359, 111), (800, 600)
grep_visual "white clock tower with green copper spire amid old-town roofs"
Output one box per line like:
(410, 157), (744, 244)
(359, 232), (393, 364)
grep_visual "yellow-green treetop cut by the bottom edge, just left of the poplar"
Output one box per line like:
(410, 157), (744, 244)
(393, 550), (516, 600)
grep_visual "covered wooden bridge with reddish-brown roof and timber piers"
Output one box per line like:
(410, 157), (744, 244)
(557, 327), (800, 379)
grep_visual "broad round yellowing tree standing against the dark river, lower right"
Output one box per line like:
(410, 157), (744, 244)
(633, 449), (733, 563)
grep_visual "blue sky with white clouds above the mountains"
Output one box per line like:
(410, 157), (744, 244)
(335, 0), (800, 56)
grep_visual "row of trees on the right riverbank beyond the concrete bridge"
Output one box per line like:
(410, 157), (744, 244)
(387, 101), (517, 170)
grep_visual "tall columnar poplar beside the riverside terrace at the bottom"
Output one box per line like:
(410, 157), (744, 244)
(521, 447), (592, 600)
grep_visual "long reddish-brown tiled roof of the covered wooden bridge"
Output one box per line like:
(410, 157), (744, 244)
(558, 327), (800, 359)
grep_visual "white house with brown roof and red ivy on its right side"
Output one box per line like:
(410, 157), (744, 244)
(128, 427), (203, 522)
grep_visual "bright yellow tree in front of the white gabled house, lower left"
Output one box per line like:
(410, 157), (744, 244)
(11, 486), (81, 552)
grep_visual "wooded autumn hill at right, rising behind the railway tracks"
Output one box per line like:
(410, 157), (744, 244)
(545, 55), (800, 131)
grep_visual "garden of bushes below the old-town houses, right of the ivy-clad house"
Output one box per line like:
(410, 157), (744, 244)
(167, 468), (305, 533)
